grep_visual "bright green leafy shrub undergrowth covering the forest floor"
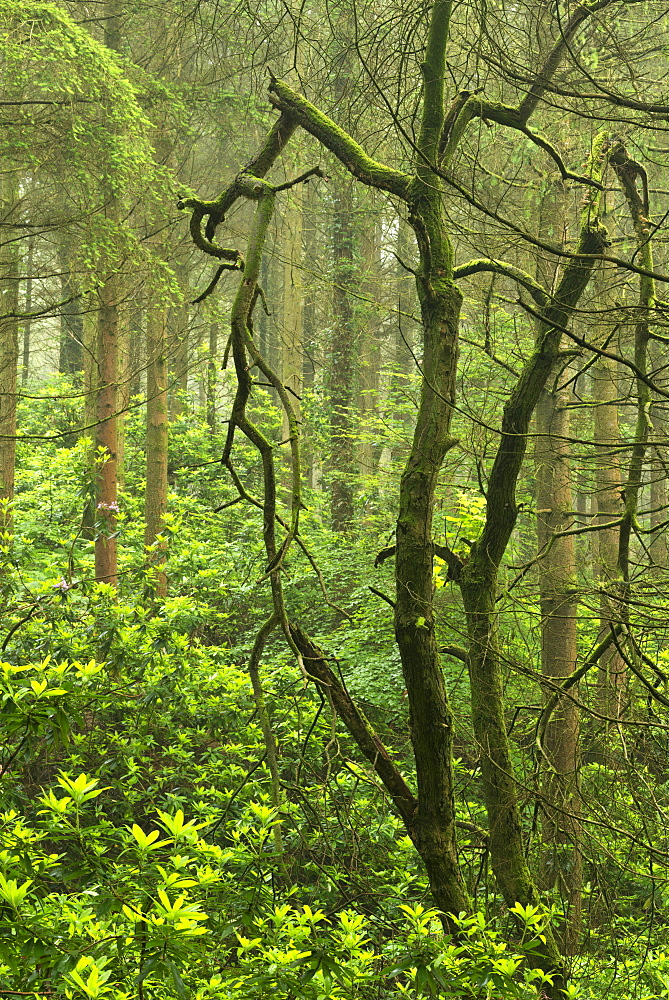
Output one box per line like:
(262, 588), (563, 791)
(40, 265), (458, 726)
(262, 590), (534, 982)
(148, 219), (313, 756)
(0, 400), (669, 1000)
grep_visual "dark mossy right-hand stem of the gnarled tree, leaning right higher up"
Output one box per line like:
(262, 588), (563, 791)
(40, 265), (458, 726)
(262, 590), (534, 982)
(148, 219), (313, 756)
(460, 180), (607, 997)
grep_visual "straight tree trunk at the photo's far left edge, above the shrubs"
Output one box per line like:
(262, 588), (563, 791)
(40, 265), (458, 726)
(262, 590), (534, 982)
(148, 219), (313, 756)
(0, 169), (19, 546)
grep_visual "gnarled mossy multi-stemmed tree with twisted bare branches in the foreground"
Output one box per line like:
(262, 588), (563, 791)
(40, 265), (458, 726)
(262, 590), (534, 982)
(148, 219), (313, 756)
(179, 2), (669, 991)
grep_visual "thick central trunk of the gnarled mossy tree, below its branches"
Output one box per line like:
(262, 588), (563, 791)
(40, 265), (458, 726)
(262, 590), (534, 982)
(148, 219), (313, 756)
(395, 272), (469, 915)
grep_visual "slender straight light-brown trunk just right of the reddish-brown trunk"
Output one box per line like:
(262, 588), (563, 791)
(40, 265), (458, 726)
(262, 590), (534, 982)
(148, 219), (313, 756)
(144, 306), (168, 597)
